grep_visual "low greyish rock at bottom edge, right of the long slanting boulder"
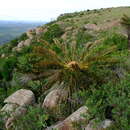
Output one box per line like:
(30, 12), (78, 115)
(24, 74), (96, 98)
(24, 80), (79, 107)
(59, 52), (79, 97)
(85, 119), (113, 130)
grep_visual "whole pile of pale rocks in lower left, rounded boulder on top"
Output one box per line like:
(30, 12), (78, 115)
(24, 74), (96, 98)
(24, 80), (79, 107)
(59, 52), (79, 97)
(1, 89), (35, 129)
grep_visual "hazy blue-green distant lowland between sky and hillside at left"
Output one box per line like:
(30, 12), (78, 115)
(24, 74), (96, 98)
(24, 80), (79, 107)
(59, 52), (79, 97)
(0, 20), (46, 44)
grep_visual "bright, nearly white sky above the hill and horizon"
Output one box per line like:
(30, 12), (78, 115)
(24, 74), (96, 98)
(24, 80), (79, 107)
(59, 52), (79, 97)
(0, 0), (130, 21)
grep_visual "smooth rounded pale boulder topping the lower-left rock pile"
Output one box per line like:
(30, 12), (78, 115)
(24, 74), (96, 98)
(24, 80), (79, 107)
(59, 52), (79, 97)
(4, 89), (35, 106)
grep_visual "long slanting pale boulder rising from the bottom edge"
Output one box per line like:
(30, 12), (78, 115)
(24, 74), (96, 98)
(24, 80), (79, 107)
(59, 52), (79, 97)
(46, 106), (88, 130)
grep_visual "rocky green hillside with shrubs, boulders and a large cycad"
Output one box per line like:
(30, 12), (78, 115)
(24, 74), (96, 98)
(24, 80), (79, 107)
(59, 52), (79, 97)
(0, 7), (130, 130)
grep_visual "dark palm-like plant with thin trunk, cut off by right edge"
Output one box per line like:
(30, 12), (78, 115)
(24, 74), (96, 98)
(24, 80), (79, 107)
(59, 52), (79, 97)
(121, 15), (130, 49)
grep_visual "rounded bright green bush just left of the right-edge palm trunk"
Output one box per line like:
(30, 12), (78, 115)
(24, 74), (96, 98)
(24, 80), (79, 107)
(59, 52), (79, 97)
(103, 33), (127, 50)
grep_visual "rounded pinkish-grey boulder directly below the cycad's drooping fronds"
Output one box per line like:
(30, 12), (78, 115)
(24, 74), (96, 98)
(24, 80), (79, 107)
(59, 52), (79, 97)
(42, 89), (67, 111)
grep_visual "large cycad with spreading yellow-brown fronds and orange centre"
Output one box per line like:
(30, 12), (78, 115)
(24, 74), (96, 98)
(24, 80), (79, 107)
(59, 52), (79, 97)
(18, 39), (119, 100)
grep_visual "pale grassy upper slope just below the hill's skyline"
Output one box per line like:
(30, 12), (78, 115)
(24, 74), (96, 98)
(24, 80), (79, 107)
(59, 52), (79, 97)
(39, 7), (130, 46)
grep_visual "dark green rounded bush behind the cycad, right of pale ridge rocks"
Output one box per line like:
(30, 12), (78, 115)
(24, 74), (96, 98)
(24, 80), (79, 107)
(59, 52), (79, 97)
(43, 24), (64, 43)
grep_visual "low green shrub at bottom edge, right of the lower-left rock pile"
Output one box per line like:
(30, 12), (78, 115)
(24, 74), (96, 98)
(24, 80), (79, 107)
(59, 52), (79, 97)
(6, 106), (48, 130)
